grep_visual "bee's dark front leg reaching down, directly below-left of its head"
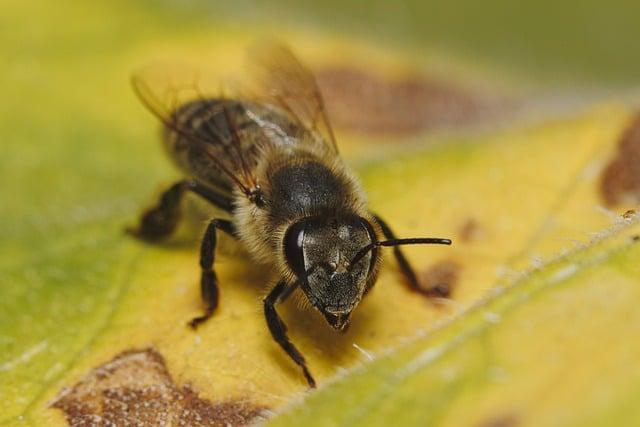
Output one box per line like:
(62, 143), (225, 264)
(264, 281), (316, 388)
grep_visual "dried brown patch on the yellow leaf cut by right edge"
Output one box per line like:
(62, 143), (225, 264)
(600, 114), (640, 206)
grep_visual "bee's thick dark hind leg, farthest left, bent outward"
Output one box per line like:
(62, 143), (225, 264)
(127, 179), (231, 241)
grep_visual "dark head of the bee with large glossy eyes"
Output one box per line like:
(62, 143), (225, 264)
(283, 216), (377, 330)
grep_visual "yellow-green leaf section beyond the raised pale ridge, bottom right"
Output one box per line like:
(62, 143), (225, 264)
(268, 215), (640, 426)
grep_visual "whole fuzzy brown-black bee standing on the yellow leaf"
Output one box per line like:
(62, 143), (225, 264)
(130, 43), (451, 387)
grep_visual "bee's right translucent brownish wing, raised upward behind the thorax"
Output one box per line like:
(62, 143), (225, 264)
(249, 42), (338, 154)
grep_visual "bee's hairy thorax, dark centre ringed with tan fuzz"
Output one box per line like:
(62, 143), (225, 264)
(234, 147), (367, 273)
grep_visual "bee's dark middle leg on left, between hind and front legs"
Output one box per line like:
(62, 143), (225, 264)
(189, 219), (235, 329)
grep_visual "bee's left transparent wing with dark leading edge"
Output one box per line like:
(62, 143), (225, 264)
(131, 64), (256, 195)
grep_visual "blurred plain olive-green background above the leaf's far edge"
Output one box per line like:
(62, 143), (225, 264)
(169, 0), (640, 86)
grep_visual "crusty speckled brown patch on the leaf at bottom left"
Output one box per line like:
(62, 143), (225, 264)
(51, 349), (265, 427)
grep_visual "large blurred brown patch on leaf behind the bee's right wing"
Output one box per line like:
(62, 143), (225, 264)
(316, 66), (515, 134)
